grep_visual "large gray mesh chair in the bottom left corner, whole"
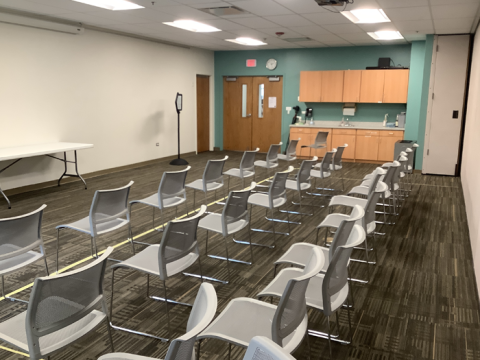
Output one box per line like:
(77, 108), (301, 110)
(0, 247), (114, 360)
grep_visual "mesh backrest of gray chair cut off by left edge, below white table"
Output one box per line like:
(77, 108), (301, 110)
(0, 205), (47, 261)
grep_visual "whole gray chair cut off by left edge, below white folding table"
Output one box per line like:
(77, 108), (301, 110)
(0, 205), (49, 303)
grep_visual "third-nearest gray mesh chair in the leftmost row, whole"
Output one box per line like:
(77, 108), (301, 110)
(130, 166), (191, 245)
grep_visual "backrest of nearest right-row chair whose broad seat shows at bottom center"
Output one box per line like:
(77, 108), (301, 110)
(272, 248), (325, 347)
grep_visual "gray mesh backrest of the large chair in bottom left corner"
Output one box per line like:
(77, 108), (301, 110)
(25, 247), (113, 360)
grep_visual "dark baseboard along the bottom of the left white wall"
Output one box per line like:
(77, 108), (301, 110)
(4, 151), (196, 196)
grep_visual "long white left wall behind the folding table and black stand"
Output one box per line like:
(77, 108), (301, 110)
(0, 24), (214, 189)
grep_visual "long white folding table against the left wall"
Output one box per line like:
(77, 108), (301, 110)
(0, 142), (93, 209)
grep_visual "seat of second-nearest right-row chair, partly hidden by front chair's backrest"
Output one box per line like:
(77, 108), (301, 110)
(257, 268), (348, 311)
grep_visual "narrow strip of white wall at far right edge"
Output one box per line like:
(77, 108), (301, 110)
(461, 31), (480, 289)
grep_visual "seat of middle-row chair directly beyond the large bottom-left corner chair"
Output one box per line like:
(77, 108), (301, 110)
(112, 244), (199, 280)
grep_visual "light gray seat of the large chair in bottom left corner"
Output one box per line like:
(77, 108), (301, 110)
(0, 306), (106, 355)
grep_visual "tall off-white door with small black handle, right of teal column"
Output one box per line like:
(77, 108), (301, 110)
(422, 35), (470, 175)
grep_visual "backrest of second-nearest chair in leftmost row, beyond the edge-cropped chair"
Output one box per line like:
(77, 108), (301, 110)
(89, 181), (133, 236)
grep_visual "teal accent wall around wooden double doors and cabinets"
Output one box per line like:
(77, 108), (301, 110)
(215, 41), (431, 169)
